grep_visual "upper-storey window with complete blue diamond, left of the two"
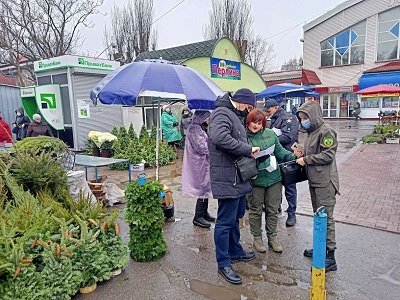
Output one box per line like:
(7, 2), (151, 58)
(321, 21), (366, 67)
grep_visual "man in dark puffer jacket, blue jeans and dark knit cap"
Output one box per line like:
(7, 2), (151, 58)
(208, 89), (260, 284)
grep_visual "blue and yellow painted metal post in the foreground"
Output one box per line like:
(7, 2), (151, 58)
(310, 206), (327, 300)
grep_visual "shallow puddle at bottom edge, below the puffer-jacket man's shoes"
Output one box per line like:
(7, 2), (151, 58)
(184, 278), (257, 300)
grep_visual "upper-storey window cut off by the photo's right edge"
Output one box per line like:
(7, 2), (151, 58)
(376, 6), (400, 61)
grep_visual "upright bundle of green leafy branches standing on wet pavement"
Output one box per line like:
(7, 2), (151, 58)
(125, 181), (167, 261)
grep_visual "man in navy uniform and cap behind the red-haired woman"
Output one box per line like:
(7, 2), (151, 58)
(265, 99), (299, 227)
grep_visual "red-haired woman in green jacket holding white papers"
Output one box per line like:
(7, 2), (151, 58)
(246, 109), (296, 253)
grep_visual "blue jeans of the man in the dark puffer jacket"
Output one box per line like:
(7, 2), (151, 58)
(214, 196), (246, 268)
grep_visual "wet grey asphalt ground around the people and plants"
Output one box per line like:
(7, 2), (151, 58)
(76, 121), (400, 300)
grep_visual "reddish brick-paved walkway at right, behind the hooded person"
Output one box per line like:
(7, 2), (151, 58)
(297, 144), (400, 233)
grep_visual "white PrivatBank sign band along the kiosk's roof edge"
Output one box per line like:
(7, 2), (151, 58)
(34, 55), (120, 72)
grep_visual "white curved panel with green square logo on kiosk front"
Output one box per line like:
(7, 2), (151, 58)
(35, 84), (64, 130)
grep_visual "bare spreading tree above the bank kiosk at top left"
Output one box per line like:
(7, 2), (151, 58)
(0, 0), (103, 84)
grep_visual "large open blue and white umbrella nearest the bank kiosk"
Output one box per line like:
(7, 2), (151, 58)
(90, 60), (224, 109)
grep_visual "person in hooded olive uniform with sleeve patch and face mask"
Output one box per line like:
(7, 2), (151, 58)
(297, 101), (339, 272)
